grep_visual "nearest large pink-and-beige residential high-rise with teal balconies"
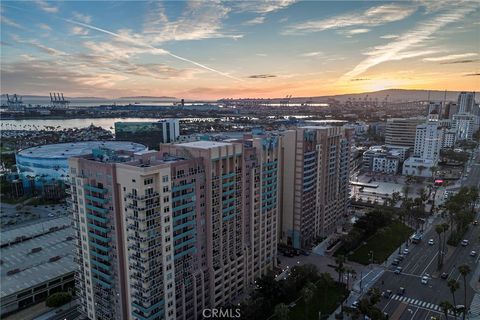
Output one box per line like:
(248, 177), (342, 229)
(69, 134), (282, 319)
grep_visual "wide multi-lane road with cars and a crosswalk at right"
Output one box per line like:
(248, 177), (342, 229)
(374, 148), (480, 320)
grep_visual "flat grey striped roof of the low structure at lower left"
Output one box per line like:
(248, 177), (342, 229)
(0, 217), (77, 298)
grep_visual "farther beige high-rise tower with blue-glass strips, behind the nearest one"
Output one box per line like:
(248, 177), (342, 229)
(280, 126), (353, 248)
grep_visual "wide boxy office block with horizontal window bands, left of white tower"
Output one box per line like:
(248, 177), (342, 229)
(385, 117), (425, 148)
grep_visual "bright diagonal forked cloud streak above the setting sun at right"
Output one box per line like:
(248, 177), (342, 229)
(343, 5), (475, 78)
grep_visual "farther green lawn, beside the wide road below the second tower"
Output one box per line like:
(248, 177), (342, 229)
(349, 221), (413, 265)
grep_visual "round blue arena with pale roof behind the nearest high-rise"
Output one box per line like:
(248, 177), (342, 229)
(16, 141), (147, 181)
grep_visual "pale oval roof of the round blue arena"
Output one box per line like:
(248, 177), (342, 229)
(18, 141), (147, 159)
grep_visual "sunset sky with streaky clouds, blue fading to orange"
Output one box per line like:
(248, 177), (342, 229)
(0, 0), (480, 99)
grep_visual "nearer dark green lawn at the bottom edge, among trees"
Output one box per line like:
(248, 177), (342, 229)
(289, 286), (348, 320)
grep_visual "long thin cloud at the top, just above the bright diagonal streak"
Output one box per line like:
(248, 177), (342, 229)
(283, 4), (416, 34)
